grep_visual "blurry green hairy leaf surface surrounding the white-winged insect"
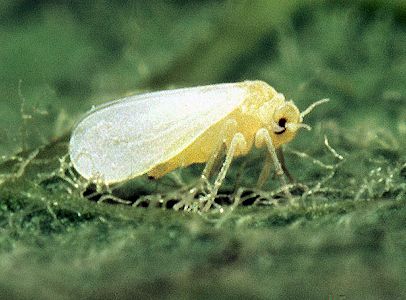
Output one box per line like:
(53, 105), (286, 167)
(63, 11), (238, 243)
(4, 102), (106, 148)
(0, 0), (406, 299)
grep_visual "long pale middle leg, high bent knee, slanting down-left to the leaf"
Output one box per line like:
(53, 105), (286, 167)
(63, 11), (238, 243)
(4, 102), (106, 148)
(203, 132), (247, 211)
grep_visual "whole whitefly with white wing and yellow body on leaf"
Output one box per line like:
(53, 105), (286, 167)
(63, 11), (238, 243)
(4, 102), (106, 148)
(69, 81), (328, 210)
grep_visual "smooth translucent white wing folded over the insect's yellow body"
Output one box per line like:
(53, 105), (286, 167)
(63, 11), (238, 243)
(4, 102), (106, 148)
(70, 83), (248, 183)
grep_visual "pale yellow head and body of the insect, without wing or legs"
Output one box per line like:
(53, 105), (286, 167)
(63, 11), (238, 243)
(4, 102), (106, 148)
(148, 81), (301, 178)
